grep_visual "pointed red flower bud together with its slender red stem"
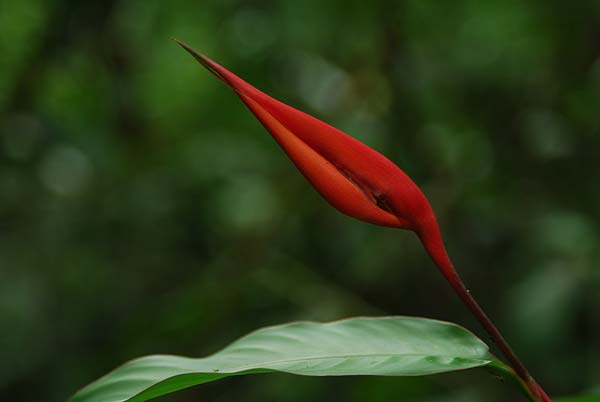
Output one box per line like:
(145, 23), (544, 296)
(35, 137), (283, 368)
(177, 41), (551, 402)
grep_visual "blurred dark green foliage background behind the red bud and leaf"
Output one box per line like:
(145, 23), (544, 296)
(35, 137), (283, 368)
(0, 0), (600, 402)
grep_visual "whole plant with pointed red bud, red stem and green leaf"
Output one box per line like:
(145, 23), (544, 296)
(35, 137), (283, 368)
(64, 41), (600, 402)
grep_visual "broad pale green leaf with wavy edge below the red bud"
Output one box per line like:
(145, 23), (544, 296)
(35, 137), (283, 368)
(71, 317), (493, 402)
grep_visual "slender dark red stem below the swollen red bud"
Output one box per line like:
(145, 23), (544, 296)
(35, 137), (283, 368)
(417, 218), (552, 402)
